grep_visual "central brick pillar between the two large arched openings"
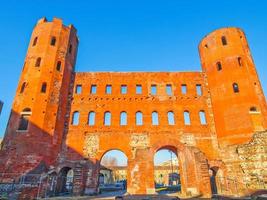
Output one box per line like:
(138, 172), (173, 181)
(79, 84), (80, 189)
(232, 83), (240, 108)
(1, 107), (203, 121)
(127, 148), (155, 194)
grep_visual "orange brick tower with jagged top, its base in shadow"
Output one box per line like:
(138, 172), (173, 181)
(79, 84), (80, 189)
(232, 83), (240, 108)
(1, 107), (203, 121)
(0, 18), (78, 173)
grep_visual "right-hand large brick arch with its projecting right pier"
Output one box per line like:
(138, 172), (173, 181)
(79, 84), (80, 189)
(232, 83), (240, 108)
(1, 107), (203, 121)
(151, 138), (211, 197)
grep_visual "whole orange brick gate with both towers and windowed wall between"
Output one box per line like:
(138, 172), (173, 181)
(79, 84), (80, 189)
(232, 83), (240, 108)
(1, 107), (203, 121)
(0, 18), (267, 197)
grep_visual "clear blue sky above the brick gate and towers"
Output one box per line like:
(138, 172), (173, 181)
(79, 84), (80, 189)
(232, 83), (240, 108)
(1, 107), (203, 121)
(0, 0), (267, 142)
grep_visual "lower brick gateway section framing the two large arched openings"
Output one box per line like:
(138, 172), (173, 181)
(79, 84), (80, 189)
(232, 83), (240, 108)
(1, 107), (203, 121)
(80, 133), (211, 196)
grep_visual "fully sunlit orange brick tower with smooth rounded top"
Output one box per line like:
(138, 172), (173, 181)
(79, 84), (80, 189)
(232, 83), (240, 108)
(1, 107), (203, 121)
(199, 28), (267, 145)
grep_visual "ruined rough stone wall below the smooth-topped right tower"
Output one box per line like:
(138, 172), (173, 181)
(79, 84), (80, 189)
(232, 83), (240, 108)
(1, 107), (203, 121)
(220, 131), (267, 193)
